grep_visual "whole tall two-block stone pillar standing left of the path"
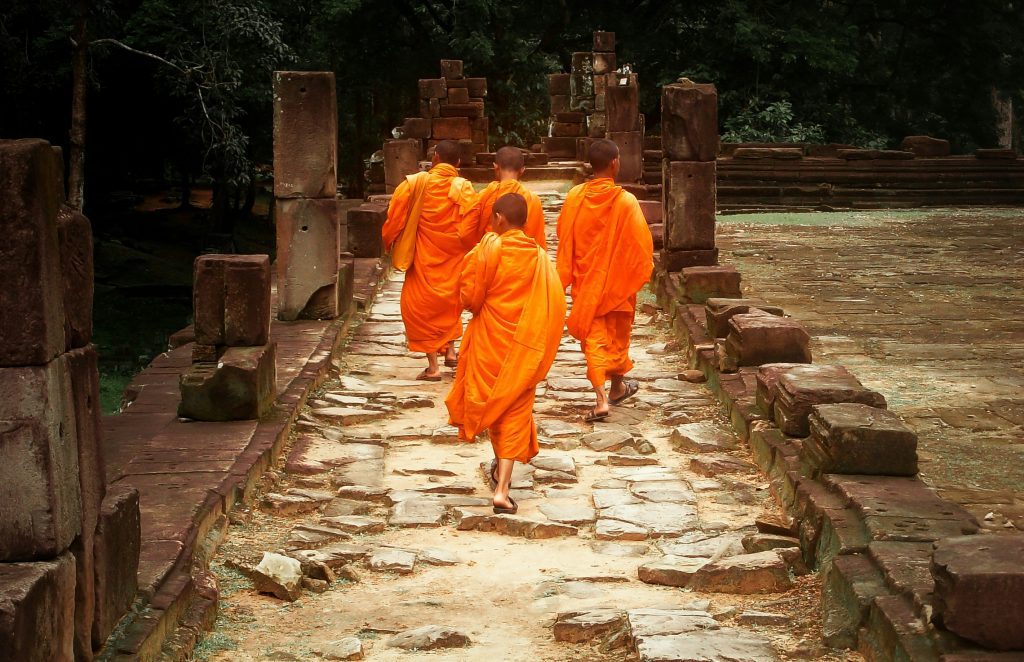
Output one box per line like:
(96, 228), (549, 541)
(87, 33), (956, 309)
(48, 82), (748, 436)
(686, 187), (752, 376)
(273, 72), (339, 321)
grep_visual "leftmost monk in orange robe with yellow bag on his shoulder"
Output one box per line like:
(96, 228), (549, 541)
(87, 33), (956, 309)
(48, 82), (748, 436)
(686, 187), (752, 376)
(381, 140), (479, 381)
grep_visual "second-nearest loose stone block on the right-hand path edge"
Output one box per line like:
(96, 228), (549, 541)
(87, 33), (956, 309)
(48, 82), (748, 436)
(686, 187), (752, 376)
(801, 403), (918, 475)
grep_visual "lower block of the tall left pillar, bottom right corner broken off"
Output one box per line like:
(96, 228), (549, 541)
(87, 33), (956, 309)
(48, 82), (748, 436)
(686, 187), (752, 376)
(274, 198), (341, 321)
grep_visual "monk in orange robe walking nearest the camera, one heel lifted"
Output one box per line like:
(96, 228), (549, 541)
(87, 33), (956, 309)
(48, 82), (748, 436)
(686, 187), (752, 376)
(444, 193), (565, 514)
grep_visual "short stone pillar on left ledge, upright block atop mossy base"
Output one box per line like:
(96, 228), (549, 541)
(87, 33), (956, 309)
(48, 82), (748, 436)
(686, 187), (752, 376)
(178, 254), (276, 421)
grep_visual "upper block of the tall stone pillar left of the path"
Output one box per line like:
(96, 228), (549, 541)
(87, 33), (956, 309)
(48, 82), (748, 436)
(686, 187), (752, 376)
(273, 72), (338, 198)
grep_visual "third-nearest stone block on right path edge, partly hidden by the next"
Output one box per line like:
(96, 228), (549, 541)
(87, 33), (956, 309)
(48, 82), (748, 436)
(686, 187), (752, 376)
(774, 364), (886, 437)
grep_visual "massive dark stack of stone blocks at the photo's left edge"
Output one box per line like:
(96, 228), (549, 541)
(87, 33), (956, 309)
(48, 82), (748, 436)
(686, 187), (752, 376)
(0, 139), (138, 660)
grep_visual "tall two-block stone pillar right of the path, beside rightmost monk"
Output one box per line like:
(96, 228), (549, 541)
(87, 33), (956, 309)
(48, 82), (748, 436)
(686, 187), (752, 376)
(660, 79), (724, 278)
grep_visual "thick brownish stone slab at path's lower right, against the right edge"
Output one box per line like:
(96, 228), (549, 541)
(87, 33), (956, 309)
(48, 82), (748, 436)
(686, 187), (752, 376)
(689, 550), (793, 595)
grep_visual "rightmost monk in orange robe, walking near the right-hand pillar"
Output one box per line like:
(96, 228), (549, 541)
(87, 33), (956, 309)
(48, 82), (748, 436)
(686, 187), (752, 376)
(557, 139), (654, 422)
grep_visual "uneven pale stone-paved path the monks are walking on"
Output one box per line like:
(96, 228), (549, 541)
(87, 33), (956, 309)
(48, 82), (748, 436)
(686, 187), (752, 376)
(198, 198), (859, 661)
